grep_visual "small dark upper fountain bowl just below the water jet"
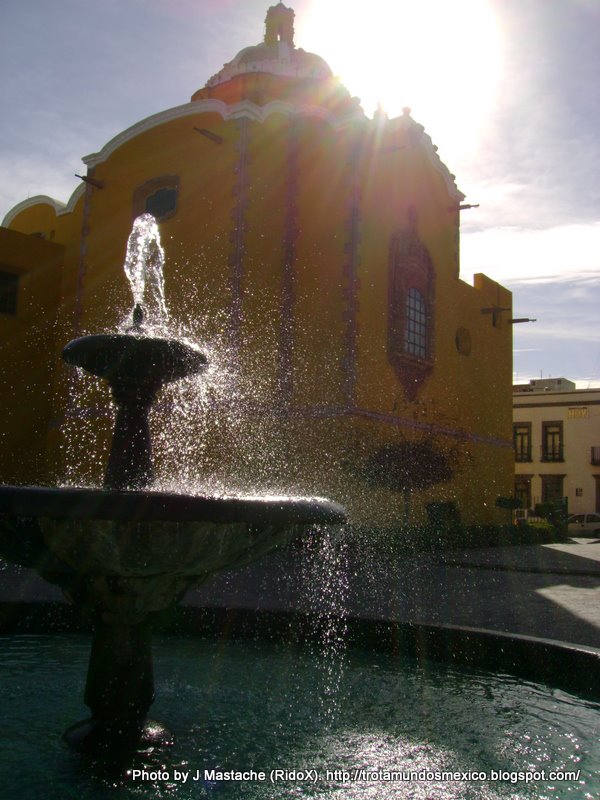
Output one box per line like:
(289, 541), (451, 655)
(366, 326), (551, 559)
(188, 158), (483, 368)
(63, 333), (207, 386)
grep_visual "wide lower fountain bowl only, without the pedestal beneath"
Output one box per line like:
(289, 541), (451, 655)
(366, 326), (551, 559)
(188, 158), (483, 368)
(0, 486), (345, 623)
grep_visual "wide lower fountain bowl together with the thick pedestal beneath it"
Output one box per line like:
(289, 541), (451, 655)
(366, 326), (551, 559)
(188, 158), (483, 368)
(0, 486), (345, 760)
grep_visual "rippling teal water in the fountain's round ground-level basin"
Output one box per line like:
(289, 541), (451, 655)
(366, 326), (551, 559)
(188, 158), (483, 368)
(0, 634), (600, 800)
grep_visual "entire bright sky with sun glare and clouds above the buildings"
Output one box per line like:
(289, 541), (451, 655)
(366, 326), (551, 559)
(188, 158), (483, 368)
(0, 0), (600, 388)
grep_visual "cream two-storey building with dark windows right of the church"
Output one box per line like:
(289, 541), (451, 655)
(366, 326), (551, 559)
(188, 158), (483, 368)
(513, 378), (600, 514)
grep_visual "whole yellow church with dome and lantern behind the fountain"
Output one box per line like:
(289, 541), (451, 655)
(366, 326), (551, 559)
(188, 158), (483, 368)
(0, 3), (514, 527)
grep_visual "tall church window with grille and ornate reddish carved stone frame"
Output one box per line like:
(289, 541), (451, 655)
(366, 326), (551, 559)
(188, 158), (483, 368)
(388, 208), (435, 400)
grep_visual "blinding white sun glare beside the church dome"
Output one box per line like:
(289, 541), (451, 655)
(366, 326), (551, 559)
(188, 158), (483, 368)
(296, 0), (502, 166)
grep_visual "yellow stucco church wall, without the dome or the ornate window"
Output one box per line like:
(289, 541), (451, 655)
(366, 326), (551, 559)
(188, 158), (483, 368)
(1, 101), (512, 525)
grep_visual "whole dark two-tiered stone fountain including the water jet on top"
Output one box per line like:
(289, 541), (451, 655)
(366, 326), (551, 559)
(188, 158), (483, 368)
(0, 215), (344, 753)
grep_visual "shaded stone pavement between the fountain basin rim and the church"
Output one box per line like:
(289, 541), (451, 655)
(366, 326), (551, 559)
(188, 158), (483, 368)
(0, 539), (600, 648)
